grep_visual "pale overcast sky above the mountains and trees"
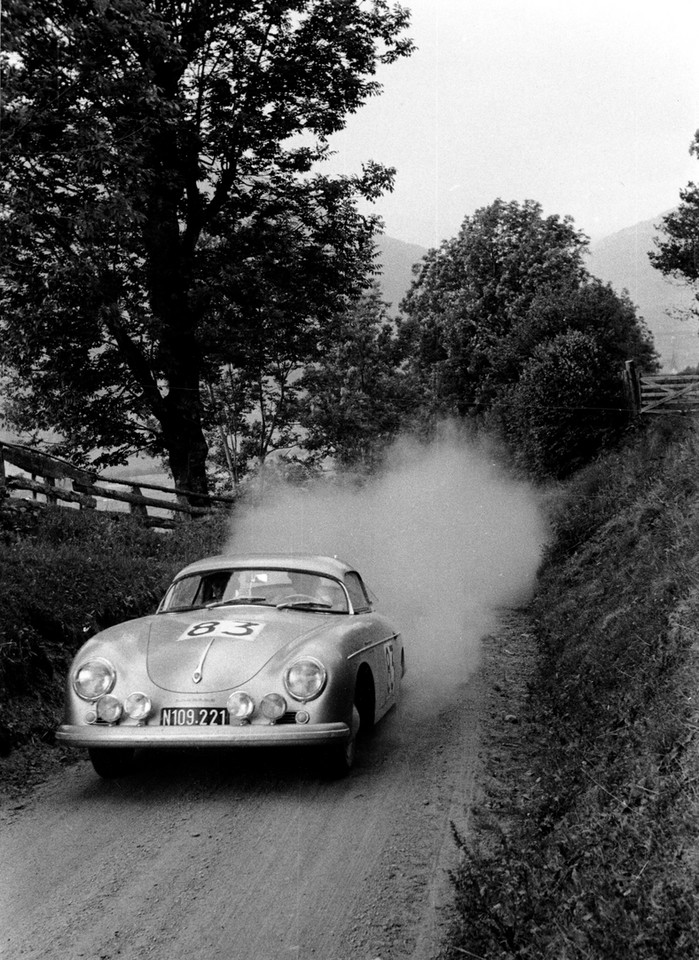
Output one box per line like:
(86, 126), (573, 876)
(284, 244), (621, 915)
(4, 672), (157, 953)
(327, 0), (699, 247)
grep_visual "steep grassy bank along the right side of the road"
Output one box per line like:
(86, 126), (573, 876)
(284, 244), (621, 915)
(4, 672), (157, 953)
(447, 424), (699, 960)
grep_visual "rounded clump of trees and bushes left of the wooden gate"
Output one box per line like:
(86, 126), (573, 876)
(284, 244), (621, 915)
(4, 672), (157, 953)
(401, 200), (656, 474)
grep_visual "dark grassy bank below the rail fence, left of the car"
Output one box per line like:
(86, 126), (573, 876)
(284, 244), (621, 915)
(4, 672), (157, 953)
(0, 508), (227, 754)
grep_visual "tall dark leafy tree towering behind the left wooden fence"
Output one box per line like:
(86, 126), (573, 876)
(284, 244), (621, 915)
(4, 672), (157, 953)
(0, 0), (411, 493)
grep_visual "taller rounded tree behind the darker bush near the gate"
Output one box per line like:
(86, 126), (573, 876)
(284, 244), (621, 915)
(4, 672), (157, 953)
(402, 200), (586, 414)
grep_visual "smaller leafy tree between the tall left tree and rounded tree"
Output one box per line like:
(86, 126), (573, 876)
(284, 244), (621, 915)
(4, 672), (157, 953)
(301, 287), (416, 465)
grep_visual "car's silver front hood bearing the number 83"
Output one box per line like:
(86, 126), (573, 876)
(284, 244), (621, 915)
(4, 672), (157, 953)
(147, 606), (326, 693)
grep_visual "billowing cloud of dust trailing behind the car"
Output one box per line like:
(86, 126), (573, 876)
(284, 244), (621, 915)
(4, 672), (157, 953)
(227, 431), (546, 699)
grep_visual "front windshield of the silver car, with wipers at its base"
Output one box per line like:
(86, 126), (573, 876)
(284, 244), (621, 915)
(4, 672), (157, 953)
(160, 567), (349, 613)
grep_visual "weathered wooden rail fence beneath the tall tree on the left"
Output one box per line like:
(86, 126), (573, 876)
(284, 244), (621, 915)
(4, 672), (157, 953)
(0, 441), (234, 529)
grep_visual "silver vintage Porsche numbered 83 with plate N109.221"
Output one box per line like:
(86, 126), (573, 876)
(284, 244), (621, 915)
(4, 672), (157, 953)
(56, 555), (405, 777)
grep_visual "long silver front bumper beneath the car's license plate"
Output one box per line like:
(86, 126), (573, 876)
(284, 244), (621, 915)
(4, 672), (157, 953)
(56, 723), (350, 748)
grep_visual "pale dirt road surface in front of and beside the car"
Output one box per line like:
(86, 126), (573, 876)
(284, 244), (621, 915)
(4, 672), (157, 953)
(0, 676), (481, 960)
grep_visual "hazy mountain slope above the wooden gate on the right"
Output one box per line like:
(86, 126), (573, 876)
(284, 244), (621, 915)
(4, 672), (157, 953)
(588, 214), (699, 373)
